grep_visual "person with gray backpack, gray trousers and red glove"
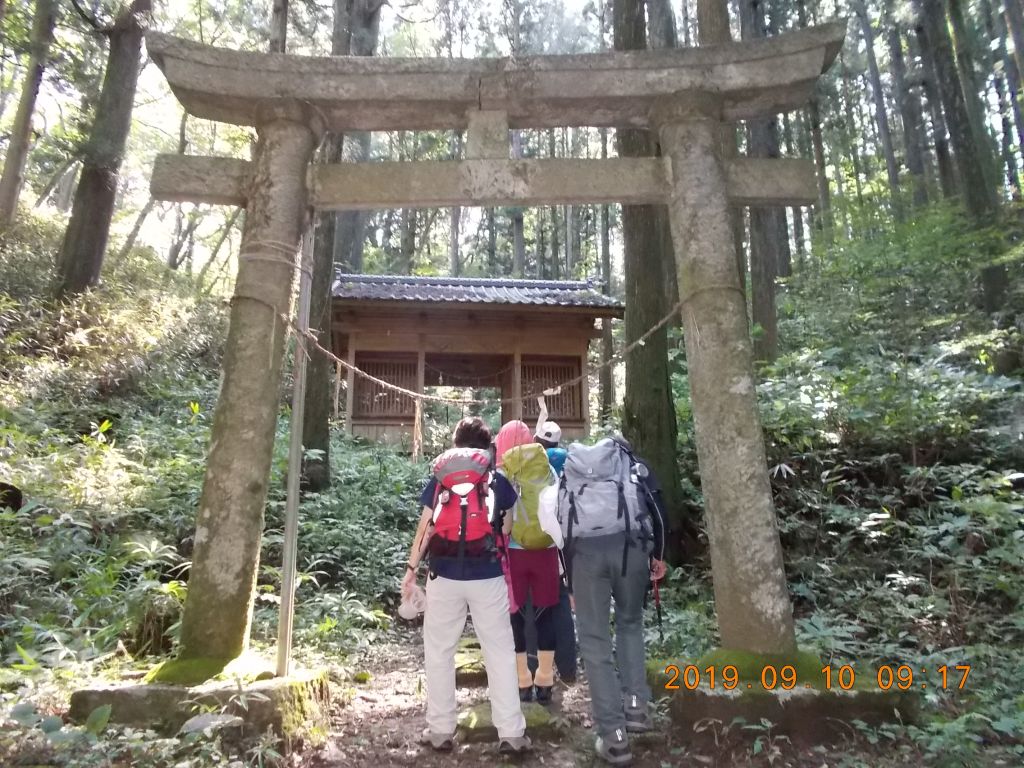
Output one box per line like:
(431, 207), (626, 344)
(558, 436), (666, 765)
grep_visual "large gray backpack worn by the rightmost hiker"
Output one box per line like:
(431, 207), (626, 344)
(558, 438), (654, 575)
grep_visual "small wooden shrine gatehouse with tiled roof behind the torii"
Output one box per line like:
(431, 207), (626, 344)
(332, 274), (624, 443)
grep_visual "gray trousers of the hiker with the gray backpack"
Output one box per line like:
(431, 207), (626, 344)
(572, 534), (650, 736)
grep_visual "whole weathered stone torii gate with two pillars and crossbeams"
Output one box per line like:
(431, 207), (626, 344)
(146, 23), (846, 671)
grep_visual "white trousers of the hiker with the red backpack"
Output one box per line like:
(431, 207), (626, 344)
(423, 577), (526, 738)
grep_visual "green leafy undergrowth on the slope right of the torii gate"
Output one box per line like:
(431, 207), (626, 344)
(659, 208), (1024, 766)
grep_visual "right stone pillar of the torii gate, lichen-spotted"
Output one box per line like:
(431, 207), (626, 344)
(652, 92), (796, 653)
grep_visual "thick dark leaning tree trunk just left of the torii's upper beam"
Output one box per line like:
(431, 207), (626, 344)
(56, 0), (153, 296)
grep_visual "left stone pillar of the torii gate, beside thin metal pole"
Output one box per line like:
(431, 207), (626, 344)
(172, 102), (323, 679)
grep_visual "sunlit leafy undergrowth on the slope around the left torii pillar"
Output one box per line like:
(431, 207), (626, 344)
(0, 219), (425, 766)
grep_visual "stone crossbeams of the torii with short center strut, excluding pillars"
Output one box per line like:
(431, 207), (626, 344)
(147, 23), (845, 210)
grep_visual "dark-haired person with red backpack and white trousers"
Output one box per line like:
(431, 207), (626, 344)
(401, 418), (531, 754)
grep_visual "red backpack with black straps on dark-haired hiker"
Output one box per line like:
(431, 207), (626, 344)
(431, 449), (495, 557)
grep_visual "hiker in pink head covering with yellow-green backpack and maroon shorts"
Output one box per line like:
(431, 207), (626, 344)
(495, 421), (561, 705)
